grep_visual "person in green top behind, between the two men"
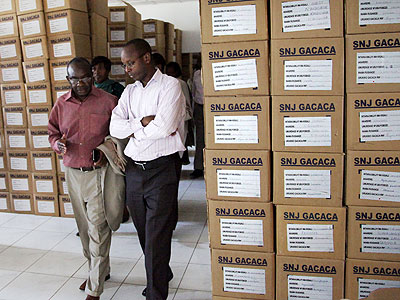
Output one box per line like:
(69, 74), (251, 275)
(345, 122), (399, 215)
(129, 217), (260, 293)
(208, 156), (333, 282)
(92, 56), (125, 99)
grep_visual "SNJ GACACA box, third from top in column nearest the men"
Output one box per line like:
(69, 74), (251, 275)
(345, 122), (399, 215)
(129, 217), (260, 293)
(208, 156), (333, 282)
(204, 96), (271, 150)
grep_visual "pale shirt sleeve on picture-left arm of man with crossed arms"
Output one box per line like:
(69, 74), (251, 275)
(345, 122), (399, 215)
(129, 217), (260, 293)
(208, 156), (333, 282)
(110, 88), (143, 139)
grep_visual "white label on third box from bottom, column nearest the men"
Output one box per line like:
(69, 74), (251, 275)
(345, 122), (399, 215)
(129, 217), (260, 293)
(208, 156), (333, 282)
(217, 170), (261, 198)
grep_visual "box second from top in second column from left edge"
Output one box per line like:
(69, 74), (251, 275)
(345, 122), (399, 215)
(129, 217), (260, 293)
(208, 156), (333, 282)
(18, 11), (46, 40)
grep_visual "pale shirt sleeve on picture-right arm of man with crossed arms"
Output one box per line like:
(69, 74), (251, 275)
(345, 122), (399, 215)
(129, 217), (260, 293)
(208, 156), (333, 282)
(135, 81), (186, 141)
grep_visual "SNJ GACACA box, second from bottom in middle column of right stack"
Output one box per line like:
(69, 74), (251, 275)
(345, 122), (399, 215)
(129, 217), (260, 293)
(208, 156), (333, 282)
(276, 205), (346, 260)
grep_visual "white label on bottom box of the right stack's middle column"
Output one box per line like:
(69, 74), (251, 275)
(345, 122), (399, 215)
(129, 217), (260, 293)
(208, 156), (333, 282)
(287, 275), (333, 300)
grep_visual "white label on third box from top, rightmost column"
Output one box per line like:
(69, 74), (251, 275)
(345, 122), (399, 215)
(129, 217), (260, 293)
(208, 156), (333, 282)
(360, 110), (400, 142)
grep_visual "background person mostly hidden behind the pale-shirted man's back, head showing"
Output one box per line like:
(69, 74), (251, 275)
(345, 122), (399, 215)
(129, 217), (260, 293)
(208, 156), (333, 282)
(165, 62), (194, 165)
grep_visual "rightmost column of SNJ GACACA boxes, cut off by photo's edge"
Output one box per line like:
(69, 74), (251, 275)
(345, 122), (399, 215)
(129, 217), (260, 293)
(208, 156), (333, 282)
(346, 0), (400, 299)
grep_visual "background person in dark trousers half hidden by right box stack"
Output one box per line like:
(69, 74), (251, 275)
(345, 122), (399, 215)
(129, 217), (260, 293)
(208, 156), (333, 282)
(190, 62), (205, 178)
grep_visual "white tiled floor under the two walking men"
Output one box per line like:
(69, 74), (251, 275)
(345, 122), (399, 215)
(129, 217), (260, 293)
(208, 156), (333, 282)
(0, 158), (211, 300)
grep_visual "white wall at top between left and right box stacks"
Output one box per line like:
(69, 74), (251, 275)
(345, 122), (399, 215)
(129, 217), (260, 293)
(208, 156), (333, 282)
(126, 0), (201, 53)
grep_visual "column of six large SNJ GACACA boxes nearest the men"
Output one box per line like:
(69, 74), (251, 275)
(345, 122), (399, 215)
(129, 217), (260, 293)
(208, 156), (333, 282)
(200, 0), (275, 299)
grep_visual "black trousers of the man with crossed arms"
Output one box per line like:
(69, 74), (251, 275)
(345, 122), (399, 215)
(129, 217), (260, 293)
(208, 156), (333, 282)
(126, 153), (182, 300)
